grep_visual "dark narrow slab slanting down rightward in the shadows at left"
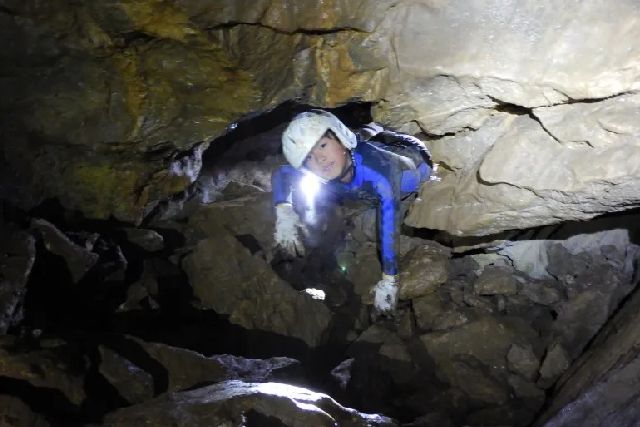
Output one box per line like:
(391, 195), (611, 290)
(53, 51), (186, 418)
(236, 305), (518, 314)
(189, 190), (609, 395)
(32, 219), (100, 283)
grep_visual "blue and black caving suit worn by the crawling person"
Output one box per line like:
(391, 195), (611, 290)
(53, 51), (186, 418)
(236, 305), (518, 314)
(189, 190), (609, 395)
(271, 131), (432, 275)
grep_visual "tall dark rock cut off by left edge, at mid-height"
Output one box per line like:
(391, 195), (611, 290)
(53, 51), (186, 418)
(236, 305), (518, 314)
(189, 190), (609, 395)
(0, 223), (36, 334)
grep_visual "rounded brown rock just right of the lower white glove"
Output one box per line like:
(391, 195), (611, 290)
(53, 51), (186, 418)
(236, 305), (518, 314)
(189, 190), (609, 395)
(399, 245), (449, 299)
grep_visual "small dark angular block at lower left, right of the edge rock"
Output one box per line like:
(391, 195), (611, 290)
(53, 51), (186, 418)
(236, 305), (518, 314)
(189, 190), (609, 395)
(98, 346), (155, 404)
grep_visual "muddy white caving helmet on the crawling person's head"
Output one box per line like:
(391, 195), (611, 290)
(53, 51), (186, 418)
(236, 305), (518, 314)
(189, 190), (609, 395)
(282, 110), (358, 169)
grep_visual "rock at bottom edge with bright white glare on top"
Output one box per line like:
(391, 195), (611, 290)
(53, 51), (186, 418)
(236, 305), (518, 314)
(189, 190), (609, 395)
(104, 381), (397, 427)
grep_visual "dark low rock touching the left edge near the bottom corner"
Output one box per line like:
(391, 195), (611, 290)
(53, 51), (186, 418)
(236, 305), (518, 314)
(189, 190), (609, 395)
(0, 335), (88, 406)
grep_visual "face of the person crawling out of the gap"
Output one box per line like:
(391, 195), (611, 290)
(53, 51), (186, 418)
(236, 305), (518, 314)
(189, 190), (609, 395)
(304, 133), (351, 180)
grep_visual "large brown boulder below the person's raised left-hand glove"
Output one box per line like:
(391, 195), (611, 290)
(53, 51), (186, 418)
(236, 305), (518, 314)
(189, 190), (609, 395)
(182, 230), (331, 346)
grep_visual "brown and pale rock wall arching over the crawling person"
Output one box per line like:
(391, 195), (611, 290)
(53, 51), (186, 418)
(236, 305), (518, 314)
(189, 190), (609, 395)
(0, 0), (640, 235)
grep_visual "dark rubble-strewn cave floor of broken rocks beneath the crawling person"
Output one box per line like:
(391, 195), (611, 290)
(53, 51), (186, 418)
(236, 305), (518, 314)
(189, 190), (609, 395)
(0, 178), (640, 426)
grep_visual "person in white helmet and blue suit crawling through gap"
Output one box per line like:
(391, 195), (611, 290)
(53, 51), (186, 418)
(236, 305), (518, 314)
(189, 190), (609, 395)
(272, 110), (433, 317)
